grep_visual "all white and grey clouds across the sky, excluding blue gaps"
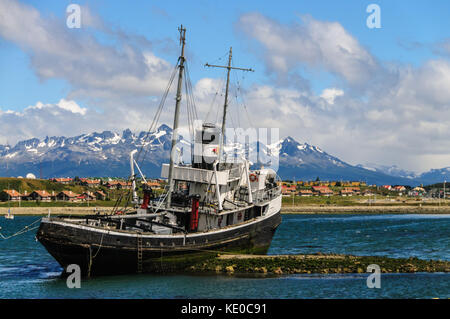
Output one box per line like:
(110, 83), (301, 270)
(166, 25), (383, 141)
(0, 0), (450, 174)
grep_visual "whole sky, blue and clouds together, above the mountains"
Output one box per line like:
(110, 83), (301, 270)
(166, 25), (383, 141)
(0, 0), (450, 173)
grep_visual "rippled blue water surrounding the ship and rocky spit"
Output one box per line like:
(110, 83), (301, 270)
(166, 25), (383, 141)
(0, 215), (450, 299)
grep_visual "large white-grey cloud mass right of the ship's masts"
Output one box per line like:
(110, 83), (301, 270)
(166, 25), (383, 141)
(237, 13), (450, 171)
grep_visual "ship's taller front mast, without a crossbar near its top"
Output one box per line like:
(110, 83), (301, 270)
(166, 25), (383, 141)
(166, 25), (186, 207)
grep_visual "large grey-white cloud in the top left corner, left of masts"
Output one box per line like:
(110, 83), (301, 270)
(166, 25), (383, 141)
(0, 0), (172, 99)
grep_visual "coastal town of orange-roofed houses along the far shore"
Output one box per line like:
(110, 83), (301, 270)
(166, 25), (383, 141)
(0, 177), (450, 206)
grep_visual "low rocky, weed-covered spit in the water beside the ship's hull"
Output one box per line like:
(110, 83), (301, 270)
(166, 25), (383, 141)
(186, 253), (450, 275)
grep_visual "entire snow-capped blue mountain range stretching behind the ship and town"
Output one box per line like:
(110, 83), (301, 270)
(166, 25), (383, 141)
(0, 125), (450, 186)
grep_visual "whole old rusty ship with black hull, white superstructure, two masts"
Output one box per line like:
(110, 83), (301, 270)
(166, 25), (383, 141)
(36, 26), (281, 276)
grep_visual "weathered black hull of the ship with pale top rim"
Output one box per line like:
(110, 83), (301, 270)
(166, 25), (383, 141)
(36, 211), (281, 276)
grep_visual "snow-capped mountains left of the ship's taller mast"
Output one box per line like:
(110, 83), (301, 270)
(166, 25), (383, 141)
(0, 125), (176, 178)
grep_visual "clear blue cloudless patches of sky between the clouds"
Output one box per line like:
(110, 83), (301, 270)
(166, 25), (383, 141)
(0, 0), (450, 110)
